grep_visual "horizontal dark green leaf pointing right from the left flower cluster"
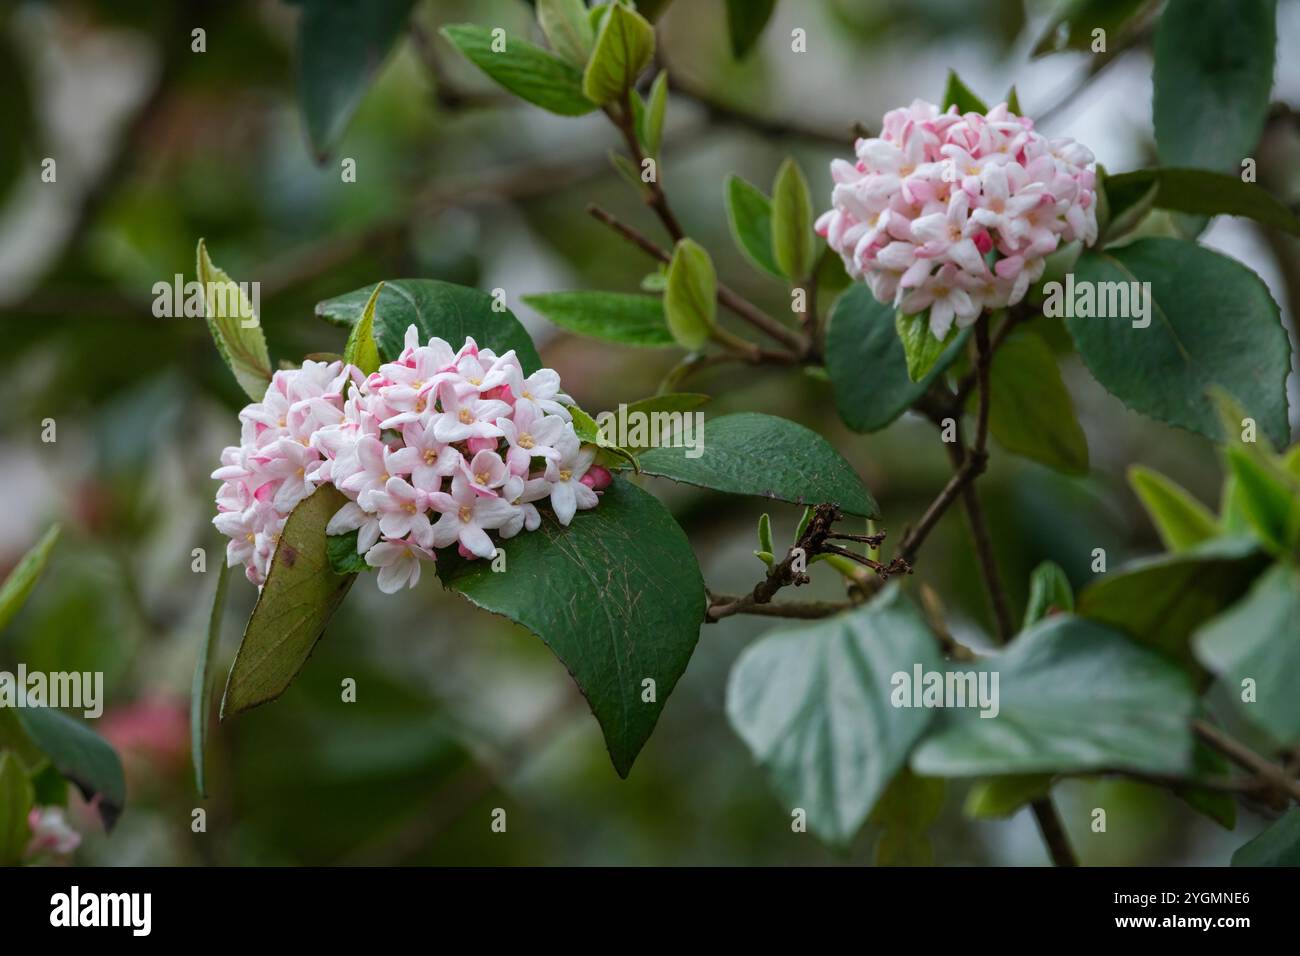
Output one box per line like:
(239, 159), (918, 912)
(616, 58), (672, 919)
(640, 412), (879, 518)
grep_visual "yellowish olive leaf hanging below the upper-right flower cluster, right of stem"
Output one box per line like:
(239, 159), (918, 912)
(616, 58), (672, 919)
(988, 329), (1088, 475)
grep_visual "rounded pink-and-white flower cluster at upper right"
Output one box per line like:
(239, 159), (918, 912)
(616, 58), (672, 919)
(816, 100), (1097, 339)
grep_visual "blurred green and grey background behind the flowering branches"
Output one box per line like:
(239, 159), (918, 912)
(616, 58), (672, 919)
(0, 0), (1300, 865)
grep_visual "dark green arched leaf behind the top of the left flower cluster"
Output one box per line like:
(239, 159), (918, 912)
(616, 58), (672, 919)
(316, 278), (542, 373)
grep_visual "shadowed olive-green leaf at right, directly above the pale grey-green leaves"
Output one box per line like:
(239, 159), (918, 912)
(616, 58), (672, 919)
(1078, 537), (1268, 671)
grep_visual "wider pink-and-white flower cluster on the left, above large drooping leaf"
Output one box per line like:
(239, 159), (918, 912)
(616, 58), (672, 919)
(212, 325), (611, 593)
